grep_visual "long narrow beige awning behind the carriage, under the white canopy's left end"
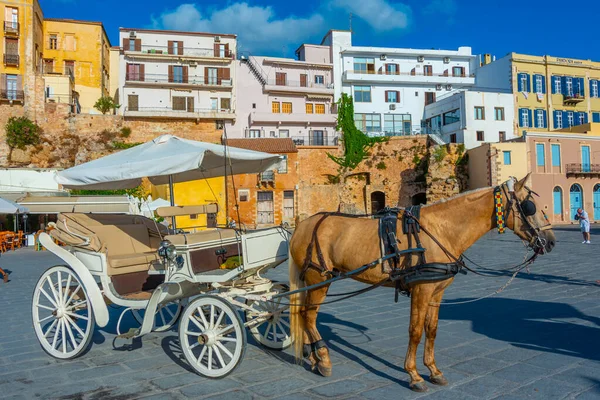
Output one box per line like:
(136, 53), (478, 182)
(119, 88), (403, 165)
(19, 196), (130, 214)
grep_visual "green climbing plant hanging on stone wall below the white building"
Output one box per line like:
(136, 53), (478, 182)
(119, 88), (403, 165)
(327, 93), (387, 169)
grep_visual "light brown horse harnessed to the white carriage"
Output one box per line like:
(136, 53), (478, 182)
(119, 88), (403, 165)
(290, 175), (555, 391)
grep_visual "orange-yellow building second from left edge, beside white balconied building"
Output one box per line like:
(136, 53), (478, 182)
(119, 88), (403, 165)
(43, 18), (110, 113)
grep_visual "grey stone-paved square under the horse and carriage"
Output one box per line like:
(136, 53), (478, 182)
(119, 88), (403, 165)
(0, 227), (600, 399)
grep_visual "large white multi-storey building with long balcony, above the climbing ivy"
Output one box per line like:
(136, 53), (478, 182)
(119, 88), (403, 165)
(321, 30), (476, 135)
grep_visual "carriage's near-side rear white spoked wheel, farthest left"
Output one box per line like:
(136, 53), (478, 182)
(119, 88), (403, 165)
(31, 266), (95, 360)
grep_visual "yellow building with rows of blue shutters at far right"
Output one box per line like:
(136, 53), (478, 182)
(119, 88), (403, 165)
(476, 53), (600, 135)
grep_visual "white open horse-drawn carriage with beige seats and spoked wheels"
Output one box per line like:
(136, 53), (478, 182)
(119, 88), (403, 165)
(32, 137), (292, 378)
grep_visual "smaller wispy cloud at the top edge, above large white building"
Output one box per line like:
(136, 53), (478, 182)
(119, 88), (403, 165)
(331, 0), (411, 32)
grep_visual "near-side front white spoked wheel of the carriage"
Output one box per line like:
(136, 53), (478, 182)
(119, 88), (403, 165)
(179, 295), (246, 378)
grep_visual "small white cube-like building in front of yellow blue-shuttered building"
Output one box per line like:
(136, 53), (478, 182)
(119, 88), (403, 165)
(424, 90), (514, 149)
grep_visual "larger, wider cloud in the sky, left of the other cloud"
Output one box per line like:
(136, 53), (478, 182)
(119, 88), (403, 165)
(153, 3), (327, 53)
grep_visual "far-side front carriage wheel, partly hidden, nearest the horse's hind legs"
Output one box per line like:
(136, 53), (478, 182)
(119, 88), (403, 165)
(245, 285), (294, 350)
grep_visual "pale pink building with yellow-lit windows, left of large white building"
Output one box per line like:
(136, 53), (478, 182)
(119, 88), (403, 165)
(228, 44), (338, 146)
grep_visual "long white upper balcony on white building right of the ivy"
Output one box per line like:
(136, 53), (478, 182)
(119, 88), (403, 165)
(344, 70), (475, 85)
